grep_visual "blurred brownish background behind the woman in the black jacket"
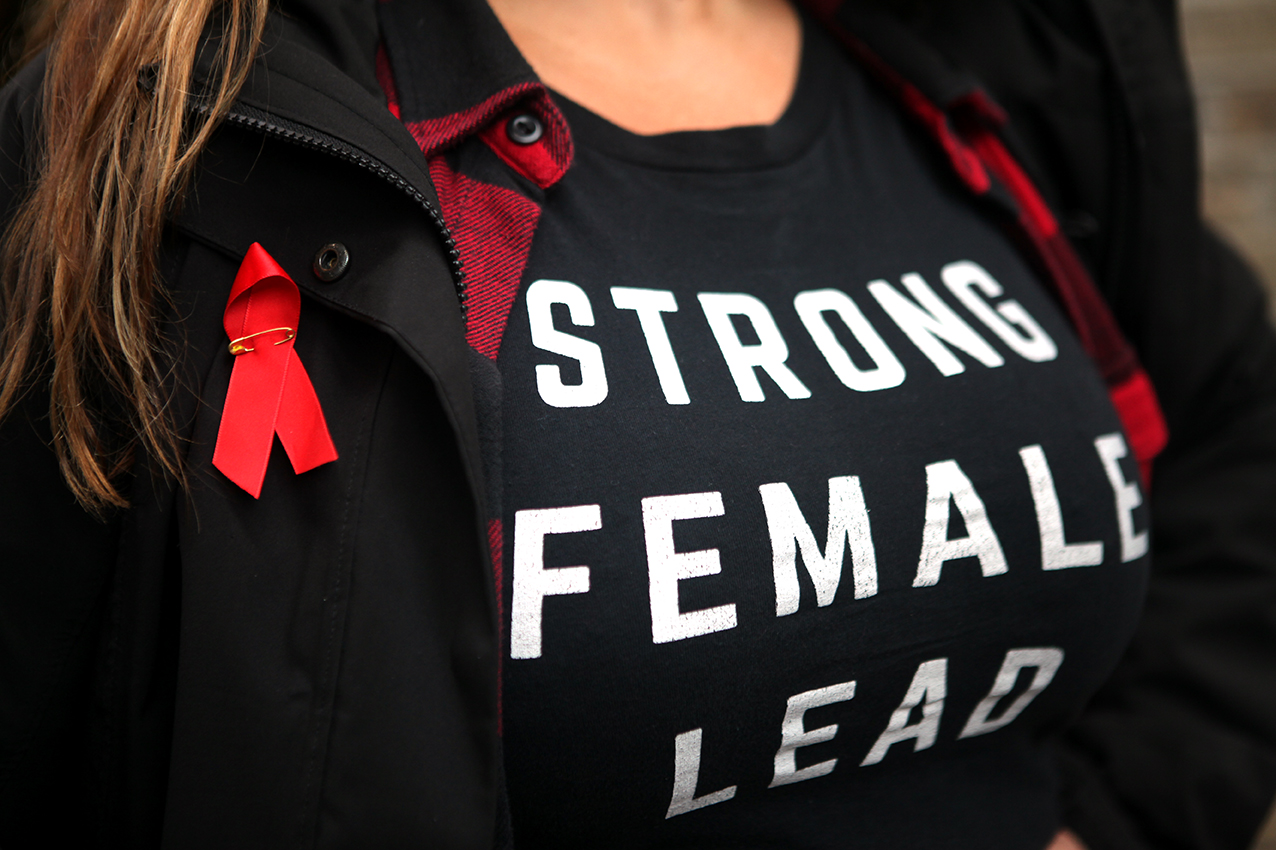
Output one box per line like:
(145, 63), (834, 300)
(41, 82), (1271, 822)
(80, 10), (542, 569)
(0, 0), (1276, 850)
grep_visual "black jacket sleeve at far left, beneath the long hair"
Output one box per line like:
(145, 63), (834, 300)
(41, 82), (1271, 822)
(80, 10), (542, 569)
(0, 56), (117, 847)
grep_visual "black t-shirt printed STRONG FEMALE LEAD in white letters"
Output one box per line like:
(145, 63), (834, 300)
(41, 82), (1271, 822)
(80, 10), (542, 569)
(498, 14), (1147, 850)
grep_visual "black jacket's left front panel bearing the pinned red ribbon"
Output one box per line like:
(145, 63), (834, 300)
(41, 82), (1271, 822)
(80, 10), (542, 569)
(165, 130), (496, 850)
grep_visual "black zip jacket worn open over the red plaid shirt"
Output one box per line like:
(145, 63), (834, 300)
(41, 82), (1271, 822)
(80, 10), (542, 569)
(0, 0), (1276, 850)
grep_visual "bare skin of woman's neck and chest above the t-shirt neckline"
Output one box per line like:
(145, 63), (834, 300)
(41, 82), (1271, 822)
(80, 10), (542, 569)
(489, 0), (801, 134)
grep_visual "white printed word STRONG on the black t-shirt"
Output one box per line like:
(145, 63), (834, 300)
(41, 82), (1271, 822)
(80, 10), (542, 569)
(527, 260), (1059, 407)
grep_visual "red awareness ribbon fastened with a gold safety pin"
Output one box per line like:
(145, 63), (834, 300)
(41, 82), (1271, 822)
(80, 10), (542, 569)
(213, 242), (337, 499)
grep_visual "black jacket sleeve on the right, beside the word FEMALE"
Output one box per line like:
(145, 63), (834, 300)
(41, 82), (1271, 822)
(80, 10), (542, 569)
(1059, 222), (1276, 850)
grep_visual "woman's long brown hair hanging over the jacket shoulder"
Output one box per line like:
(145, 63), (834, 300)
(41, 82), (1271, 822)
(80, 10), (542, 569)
(0, 0), (268, 512)
